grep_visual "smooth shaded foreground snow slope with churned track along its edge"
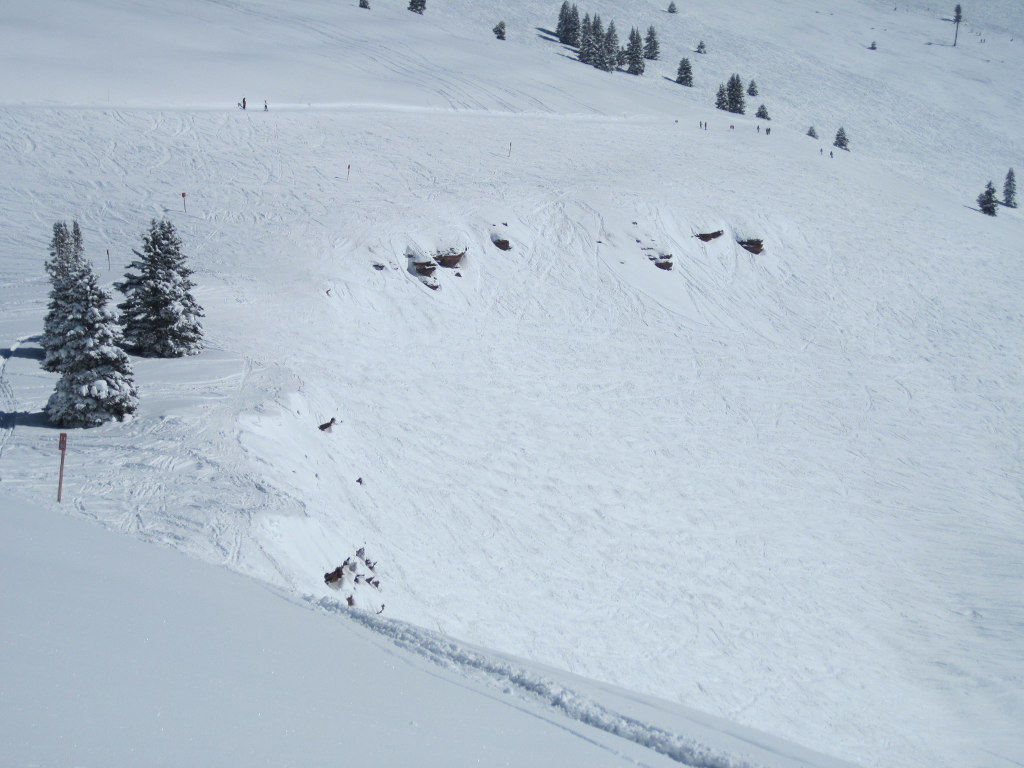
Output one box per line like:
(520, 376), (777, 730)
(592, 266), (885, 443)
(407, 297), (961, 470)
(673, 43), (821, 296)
(0, 489), (868, 768)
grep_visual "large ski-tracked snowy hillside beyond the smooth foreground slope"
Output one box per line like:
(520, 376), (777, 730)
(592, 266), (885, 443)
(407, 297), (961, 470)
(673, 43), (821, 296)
(0, 0), (1024, 768)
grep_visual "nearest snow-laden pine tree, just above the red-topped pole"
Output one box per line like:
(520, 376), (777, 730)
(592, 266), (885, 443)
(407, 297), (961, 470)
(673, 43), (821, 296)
(45, 258), (138, 427)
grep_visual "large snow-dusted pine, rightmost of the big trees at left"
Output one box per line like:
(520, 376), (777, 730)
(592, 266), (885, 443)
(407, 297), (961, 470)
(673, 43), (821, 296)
(114, 219), (203, 357)
